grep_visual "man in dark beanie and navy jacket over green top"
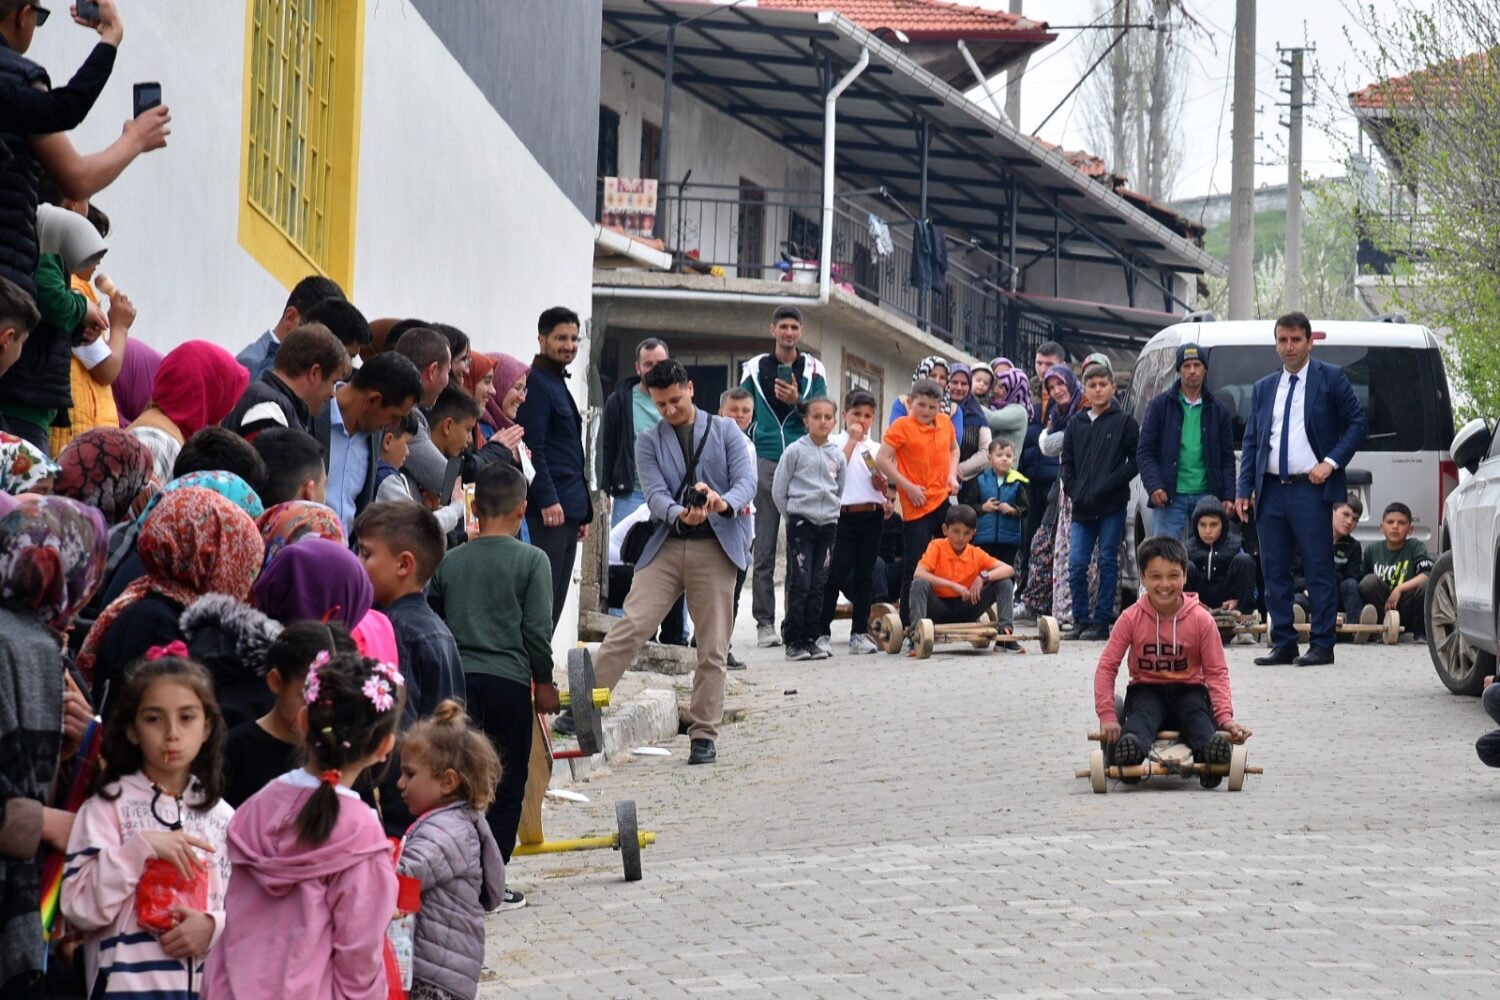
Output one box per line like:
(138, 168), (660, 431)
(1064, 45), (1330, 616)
(1136, 343), (1235, 548)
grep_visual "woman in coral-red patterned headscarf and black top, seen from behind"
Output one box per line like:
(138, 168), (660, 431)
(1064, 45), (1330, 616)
(78, 486), (264, 715)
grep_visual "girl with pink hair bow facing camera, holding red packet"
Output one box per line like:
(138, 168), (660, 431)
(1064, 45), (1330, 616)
(62, 653), (234, 997)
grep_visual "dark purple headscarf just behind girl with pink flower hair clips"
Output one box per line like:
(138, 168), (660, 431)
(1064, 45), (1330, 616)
(252, 537), (375, 628)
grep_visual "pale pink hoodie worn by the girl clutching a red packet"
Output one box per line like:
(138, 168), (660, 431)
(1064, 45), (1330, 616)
(62, 774), (232, 1000)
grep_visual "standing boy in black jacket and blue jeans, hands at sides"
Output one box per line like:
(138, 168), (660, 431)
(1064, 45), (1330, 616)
(1062, 364), (1140, 639)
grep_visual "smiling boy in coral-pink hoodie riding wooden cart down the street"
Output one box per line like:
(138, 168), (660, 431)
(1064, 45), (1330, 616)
(1094, 537), (1250, 789)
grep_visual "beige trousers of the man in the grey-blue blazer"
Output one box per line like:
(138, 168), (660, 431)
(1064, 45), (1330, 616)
(594, 538), (737, 739)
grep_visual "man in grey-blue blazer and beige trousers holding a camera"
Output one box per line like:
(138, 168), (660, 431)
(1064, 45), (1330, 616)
(594, 361), (756, 765)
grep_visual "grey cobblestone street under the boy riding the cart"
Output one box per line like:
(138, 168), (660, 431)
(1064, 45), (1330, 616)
(480, 624), (1500, 997)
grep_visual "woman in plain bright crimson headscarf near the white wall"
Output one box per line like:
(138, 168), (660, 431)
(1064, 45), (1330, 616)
(128, 340), (251, 483)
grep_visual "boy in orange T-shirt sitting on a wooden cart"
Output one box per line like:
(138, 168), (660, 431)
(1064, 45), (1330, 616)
(911, 504), (1025, 652)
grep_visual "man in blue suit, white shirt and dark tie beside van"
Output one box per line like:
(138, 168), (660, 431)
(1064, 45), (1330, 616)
(1235, 312), (1368, 667)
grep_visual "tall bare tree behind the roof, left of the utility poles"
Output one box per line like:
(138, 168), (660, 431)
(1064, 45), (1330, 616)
(1079, 0), (1187, 198)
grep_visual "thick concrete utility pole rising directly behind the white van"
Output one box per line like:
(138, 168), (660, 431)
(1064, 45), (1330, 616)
(1229, 0), (1256, 319)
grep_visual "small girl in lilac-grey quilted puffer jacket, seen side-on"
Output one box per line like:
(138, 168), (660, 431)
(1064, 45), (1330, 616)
(396, 699), (506, 1000)
